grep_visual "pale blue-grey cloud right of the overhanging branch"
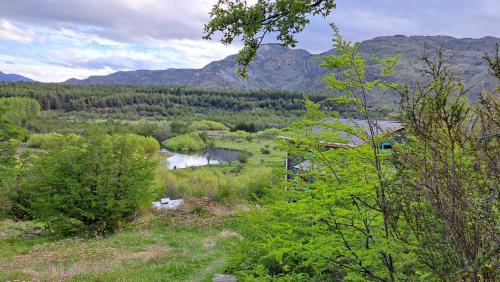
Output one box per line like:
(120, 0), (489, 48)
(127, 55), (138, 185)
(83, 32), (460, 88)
(290, 0), (500, 52)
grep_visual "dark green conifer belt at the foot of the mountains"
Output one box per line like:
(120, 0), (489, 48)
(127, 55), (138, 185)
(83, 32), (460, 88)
(0, 83), (352, 119)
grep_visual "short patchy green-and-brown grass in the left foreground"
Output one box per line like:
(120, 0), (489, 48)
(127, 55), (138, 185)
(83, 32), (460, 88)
(0, 199), (238, 281)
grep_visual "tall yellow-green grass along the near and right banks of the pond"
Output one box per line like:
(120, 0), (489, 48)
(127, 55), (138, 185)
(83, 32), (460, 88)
(155, 137), (284, 204)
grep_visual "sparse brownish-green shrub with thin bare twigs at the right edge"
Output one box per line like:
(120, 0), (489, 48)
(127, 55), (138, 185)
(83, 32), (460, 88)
(394, 49), (500, 281)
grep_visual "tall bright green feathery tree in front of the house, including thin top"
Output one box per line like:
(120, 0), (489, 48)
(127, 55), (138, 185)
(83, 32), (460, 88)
(229, 27), (420, 281)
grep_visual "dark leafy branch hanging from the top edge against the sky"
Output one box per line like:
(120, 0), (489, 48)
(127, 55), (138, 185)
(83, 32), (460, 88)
(203, 0), (336, 77)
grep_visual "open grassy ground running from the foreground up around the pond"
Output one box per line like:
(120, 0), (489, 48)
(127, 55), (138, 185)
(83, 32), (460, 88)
(0, 126), (284, 281)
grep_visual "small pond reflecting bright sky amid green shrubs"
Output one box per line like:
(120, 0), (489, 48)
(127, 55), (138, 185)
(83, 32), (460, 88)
(166, 149), (241, 169)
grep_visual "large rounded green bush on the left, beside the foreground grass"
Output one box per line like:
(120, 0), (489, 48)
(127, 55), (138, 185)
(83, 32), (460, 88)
(12, 131), (156, 236)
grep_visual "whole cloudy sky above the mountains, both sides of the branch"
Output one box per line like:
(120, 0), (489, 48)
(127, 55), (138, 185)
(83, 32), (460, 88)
(0, 0), (500, 82)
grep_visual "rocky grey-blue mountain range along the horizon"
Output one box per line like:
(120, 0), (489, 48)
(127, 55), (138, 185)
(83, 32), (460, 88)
(65, 35), (500, 97)
